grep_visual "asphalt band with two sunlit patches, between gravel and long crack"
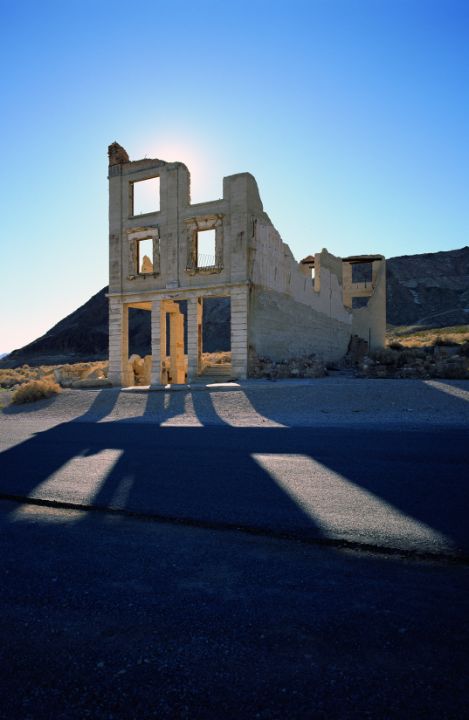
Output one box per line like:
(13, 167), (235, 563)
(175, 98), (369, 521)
(0, 421), (469, 555)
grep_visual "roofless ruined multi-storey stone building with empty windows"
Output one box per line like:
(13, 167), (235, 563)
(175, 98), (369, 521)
(109, 143), (386, 386)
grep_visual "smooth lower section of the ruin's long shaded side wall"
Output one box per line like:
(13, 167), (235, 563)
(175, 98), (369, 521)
(248, 286), (351, 362)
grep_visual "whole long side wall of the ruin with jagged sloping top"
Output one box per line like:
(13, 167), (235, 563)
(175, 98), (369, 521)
(248, 215), (352, 366)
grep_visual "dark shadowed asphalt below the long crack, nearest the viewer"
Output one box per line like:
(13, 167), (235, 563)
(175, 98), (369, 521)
(0, 502), (469, 720)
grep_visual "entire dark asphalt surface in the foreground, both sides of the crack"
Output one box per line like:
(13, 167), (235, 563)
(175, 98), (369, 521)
(0, 395), (469, 720)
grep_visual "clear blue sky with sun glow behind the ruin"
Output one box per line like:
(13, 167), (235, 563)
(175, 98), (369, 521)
(0, 0), (469, 352)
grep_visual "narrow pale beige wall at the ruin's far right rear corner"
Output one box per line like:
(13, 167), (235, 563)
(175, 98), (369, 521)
(352, 260), (386, 350)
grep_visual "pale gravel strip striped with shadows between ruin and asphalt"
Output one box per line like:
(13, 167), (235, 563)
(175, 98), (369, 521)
(0, 377), (469, 433)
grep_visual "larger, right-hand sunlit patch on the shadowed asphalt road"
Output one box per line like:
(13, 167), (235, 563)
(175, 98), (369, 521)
(252, 453), (453, 547)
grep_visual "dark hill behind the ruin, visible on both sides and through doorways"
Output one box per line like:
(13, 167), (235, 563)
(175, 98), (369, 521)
(0, 247), (469, 367)
